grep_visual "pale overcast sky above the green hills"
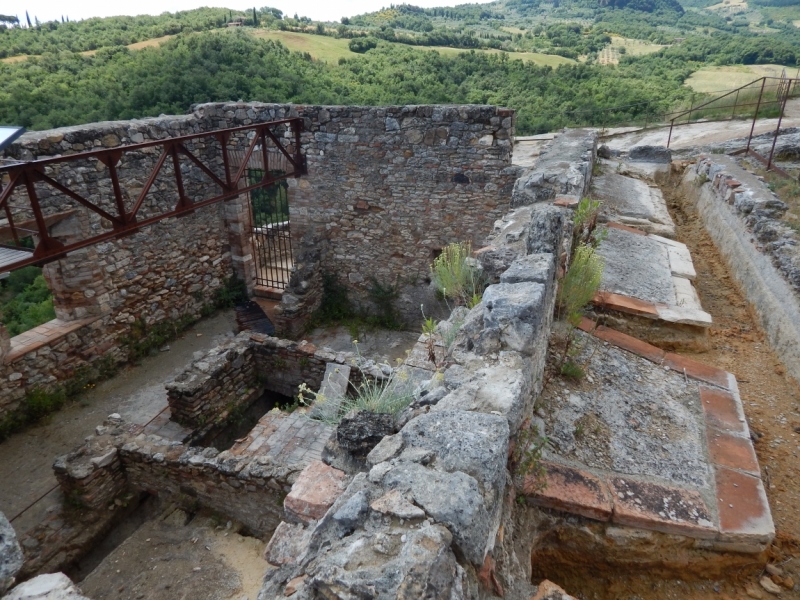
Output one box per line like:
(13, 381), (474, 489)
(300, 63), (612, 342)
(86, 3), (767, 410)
(12, 0), (488, 22)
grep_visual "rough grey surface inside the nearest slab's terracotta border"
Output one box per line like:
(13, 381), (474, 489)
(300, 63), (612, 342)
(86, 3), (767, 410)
(545, 336), (713, 490)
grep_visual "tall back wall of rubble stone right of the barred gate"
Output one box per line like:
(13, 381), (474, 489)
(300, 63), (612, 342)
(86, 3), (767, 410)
(188, 104), (518, 320)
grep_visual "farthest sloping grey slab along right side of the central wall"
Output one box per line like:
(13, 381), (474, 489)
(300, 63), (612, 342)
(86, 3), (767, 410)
(592, 173), (675, 237)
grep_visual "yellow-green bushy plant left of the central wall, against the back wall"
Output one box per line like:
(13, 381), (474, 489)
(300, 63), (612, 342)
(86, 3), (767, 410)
(431, 242), (484, 306)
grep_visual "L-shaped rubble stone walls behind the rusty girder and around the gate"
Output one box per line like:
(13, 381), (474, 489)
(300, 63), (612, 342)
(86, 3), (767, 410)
(0, 103), (517, 419)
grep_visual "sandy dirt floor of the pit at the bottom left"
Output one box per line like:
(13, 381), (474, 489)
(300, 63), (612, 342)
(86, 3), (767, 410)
(79, 506), (269, 600)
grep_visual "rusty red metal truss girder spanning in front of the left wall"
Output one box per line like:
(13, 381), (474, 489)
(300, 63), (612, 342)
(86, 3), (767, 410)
(0, 118), (306, 272)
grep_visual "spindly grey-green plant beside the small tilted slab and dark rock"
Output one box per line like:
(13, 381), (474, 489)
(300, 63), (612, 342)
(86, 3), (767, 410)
(297, 340), (414, 426)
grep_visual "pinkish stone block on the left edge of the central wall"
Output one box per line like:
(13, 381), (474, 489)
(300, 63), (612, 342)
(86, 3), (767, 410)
(283, 461), (347, 523)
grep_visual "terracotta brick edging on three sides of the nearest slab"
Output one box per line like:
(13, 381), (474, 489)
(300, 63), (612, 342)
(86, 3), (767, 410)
(522, 318), (775, 553)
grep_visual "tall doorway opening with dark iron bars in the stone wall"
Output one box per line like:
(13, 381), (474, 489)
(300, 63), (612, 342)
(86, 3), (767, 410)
(247, 169), (292, 290)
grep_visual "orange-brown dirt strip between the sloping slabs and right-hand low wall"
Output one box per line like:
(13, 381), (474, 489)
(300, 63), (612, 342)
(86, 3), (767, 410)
(544, 166), (800, 600)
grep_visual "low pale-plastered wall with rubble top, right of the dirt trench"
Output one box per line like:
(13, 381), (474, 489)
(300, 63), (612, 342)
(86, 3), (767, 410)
(681, 155), (800, 379)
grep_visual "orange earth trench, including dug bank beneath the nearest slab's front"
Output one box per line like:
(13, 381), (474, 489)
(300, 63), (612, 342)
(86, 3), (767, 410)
(517, 164), (800, 600)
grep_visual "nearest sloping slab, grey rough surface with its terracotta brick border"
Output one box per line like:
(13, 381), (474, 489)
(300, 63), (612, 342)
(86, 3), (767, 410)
(523, 319), (775, 553)
